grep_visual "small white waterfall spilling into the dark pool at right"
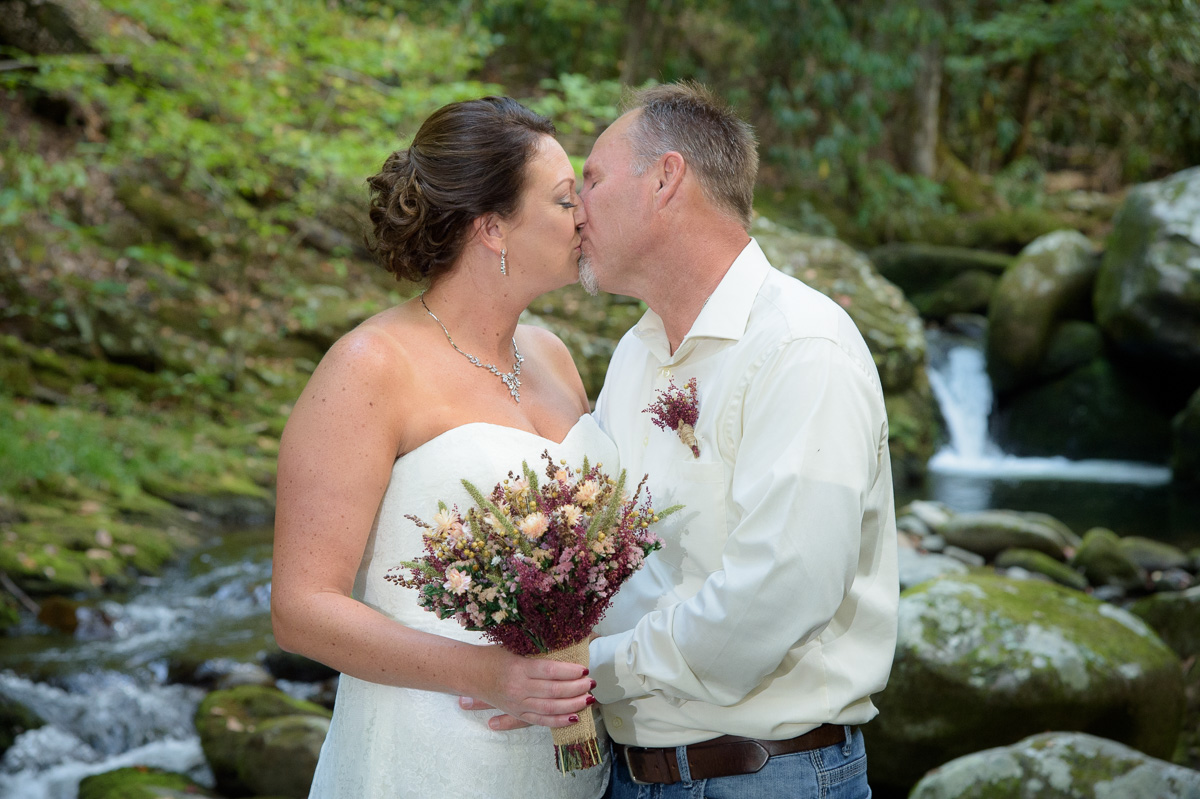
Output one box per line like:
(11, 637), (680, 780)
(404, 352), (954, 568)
(926, 330), (1171, 484)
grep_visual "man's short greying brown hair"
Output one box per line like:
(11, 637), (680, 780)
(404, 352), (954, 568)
(626, 82), (758, 230)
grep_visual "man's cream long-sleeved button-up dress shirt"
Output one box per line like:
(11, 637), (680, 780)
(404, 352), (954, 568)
(590, 240), (899, 746)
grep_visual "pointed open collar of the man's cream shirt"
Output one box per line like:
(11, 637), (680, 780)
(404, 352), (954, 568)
(634, 239), (770, 361)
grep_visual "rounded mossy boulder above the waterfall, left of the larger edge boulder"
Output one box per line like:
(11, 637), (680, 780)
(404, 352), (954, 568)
(988, 230), (1098, 394)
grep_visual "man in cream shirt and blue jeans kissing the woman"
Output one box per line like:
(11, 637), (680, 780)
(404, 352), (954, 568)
(581, 84), (899, 799)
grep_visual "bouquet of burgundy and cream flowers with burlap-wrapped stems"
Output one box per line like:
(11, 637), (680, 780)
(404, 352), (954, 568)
(386, 451), (680, 773)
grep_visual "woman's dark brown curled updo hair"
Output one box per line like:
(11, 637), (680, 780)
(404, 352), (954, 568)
(367, 97), (556, 282)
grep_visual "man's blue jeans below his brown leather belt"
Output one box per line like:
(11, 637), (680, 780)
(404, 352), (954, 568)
(605, 728), (871, 799)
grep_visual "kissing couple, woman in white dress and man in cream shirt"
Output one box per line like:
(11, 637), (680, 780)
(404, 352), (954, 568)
(271, 84), (899, 799)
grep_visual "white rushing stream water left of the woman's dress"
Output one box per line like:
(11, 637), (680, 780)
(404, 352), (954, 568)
(0, 531), (271, 799)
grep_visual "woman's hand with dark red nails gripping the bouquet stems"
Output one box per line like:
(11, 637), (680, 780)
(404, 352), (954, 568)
(458, 647), (596, 729)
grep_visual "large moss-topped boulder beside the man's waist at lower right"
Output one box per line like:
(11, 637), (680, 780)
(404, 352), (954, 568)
(864, 573), (1183, 791)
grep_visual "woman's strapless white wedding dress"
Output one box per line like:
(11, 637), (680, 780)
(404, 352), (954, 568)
(310, 415), (618, 799)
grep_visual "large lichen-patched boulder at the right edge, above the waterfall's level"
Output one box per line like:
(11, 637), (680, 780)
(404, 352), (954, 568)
(1096, 167), (1200, 376)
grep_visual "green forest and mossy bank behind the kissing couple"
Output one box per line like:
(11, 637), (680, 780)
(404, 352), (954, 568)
(0, 0), (1200, 609)
